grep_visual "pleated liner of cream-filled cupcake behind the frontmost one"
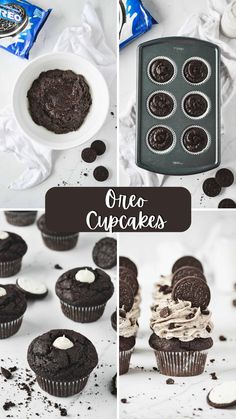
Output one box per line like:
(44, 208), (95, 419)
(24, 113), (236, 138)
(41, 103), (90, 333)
(60, 300), (106, 323)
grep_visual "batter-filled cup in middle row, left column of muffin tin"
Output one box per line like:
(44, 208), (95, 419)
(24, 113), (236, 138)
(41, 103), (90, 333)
(147, 91), (175, 118)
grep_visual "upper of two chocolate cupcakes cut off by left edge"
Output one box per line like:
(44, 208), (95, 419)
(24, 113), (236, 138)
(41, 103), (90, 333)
(0, 231), (27, 278)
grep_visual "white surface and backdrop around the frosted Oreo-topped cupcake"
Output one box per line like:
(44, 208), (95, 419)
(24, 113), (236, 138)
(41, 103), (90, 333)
(119, 212), (236, 419)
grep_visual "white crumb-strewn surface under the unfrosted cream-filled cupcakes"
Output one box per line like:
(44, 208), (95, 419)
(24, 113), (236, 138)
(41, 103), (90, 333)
(0, 213), (116, 419)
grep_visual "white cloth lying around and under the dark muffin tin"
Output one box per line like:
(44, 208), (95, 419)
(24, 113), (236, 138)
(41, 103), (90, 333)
(120, 0), (236, 186)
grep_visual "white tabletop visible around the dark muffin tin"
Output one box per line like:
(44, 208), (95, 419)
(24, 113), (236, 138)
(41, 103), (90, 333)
(119, 0), (236, 208)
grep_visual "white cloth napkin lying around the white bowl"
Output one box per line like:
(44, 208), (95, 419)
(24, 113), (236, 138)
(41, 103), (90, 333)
(0, 2), (116, 190)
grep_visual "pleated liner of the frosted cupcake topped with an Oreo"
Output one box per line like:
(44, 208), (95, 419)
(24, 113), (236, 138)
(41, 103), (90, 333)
(154, 351), (207, 377)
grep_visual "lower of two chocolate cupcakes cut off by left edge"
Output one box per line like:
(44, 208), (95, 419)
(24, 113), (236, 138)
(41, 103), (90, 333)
(0, 284), (27, 339)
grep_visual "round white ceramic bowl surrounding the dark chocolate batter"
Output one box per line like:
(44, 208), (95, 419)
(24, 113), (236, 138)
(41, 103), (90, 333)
(13, 53), (109, 150)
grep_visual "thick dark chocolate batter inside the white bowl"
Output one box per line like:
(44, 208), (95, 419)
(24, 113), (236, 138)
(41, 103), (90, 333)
(27, 69), (92, 134)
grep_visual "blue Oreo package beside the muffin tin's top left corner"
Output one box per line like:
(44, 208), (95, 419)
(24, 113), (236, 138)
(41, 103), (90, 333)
(119, 0), (157, 49)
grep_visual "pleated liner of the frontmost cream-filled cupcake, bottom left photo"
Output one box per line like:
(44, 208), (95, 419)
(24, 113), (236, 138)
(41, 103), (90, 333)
(36, 375), (89, 397)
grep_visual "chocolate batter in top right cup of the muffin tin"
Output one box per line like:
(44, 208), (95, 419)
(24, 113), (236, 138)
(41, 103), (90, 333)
(183, 59), (209, 84)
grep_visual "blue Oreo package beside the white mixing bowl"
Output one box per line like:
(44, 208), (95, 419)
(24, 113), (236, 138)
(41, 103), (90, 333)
(0, 0), (51, 58)
